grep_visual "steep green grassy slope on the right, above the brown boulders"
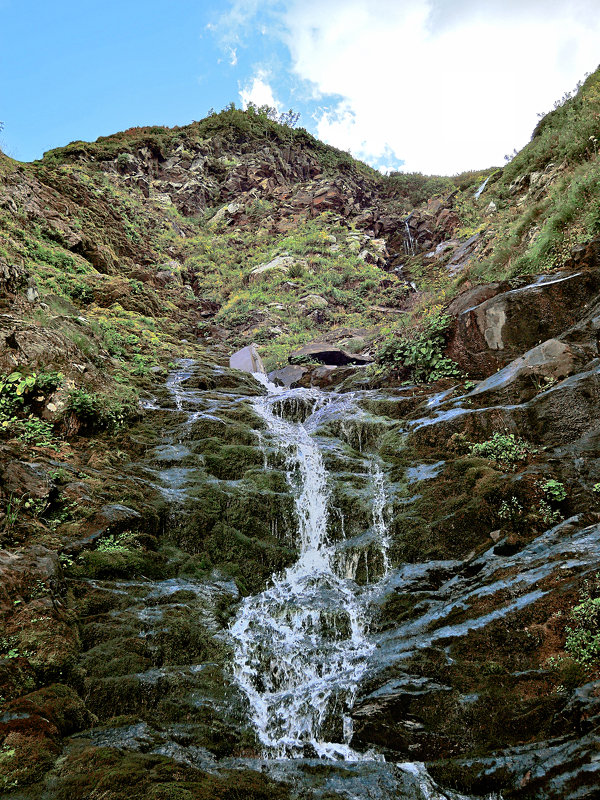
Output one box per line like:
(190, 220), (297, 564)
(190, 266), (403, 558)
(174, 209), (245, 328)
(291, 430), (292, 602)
(372, 69), (600, 368)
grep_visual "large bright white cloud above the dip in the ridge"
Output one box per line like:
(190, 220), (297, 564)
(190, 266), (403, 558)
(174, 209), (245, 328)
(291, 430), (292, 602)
(285, 0), (600, 173)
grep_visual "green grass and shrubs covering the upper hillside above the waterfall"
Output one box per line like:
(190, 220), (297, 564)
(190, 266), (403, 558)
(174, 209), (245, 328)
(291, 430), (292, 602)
(0, 67), (600, 412)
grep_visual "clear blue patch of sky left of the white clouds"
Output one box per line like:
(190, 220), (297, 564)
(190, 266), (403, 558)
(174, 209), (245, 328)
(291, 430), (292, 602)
(0, 0), (239, 160)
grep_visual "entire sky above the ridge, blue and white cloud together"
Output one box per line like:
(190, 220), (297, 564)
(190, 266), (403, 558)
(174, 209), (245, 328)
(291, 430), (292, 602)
(0, 0), (600, 174)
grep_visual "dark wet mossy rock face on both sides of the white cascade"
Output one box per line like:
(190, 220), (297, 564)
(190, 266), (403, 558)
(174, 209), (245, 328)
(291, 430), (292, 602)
(2, 351), (600, 800)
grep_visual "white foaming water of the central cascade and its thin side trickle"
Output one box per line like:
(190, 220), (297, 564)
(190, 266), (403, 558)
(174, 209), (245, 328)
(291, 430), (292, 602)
(231, 376), (387, 761)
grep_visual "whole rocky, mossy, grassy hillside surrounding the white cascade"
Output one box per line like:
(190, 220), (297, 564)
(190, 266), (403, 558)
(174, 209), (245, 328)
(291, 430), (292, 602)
(0, 71), (600, 800)
